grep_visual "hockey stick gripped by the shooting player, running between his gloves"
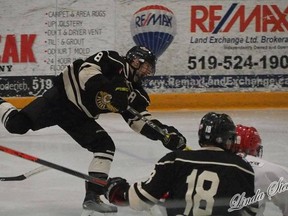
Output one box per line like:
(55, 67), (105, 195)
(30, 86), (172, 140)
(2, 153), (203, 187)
(127, 106), (191, 150)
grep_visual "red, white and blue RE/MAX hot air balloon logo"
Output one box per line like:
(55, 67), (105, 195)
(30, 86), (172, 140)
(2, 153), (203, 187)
(130, 5), (176, 58)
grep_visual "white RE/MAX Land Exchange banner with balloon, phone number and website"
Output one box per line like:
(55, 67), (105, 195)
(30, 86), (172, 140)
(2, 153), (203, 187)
(120, 0), (288, 92)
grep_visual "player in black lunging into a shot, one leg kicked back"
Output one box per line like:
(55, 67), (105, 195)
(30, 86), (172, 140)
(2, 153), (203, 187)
(0, 46), (186, 212)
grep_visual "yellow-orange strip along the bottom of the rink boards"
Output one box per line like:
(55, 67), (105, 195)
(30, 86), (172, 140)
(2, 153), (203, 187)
(4, 92), (288, 110)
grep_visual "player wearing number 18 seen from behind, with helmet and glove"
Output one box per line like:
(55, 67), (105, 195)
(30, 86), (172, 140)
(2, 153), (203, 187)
(105, 112), (257, 216)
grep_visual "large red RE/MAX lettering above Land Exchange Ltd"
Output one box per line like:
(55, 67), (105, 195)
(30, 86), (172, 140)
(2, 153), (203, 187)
(191, 3), (288, 34)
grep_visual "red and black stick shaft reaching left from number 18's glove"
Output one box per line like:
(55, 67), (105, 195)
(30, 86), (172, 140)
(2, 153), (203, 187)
(0, 145), (107, 187)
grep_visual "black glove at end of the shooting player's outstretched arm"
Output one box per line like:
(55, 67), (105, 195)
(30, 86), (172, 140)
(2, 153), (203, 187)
(161, 126), (186, 151)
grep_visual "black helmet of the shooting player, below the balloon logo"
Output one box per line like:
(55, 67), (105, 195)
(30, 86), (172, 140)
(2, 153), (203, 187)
(126, 46), (157, 75)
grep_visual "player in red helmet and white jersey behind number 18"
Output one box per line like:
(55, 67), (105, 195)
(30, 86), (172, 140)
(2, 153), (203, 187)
(235, 124), (288, 216)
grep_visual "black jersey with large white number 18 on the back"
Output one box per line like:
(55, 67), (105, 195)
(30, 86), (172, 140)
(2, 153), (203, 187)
(129, 147), (254, 216)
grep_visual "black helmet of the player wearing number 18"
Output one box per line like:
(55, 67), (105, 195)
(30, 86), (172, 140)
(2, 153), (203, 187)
(198, 112), (236, 150)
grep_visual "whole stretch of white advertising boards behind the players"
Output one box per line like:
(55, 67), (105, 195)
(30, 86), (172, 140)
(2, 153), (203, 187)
(0, 0), (288, 97)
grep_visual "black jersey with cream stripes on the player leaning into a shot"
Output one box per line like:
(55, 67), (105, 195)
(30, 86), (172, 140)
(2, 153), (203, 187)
(55, 51), (166, 140)
